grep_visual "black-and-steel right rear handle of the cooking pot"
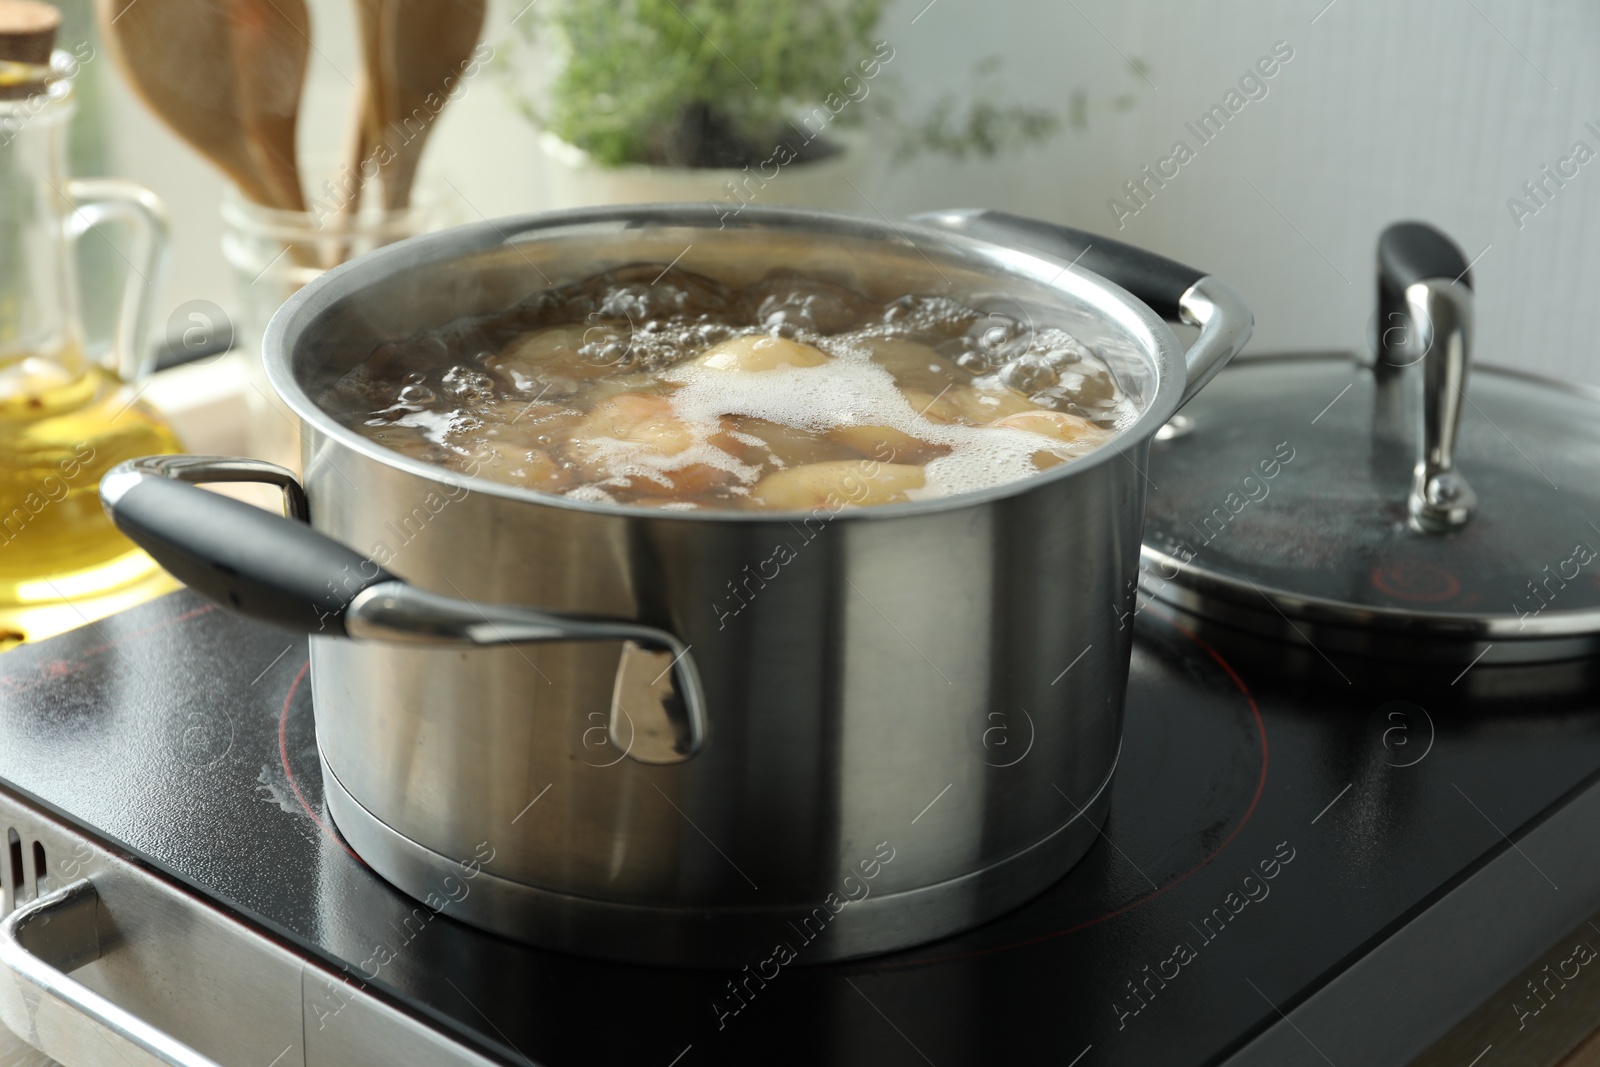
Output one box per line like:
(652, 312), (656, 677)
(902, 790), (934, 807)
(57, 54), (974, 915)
(914, 210), (1254, 403)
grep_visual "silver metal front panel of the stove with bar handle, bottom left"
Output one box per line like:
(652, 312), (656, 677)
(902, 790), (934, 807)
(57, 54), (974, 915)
(0, 789), (512, 1067)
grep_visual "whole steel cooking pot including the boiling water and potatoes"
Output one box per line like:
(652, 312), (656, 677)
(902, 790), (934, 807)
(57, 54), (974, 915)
(102, 206), (1250, 966)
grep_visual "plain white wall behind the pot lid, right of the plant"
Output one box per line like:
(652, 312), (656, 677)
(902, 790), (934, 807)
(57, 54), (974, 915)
(880, 0), (1600, 382)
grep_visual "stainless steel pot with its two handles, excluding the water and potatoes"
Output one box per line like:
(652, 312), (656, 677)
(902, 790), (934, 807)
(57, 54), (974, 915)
(102, 206), (1251, 968)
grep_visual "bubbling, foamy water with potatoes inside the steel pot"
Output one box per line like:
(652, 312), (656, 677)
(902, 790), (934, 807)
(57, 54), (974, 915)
(320, 264), (1134, 510)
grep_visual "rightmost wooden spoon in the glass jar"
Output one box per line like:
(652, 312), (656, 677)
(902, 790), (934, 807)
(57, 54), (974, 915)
(363, 0), (485, 211)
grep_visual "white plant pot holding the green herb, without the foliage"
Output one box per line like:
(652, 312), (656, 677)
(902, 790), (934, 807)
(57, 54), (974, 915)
(539, 131), (872, 214)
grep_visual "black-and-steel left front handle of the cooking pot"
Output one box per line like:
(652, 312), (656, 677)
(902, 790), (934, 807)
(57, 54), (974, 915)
(99, 456), (706, 763)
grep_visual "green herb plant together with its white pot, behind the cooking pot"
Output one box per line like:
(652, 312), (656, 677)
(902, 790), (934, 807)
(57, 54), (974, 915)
(501, 0), (1113, 211)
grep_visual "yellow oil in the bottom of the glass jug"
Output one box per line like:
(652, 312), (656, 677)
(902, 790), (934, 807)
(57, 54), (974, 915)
(0, 355), (181, 648)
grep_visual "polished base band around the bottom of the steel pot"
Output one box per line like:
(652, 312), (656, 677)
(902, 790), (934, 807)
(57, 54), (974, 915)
(318, 741), (1122, 966)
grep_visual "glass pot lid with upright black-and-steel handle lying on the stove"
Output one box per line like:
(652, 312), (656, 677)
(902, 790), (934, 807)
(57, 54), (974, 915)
(1141, 224), (1600, 662)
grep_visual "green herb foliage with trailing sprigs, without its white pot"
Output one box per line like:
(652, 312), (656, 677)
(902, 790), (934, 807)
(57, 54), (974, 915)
(501, 0), (1144, 166)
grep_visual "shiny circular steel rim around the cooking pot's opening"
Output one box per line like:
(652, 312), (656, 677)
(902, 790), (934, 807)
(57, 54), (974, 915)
(262, 203), (1187, 523)
